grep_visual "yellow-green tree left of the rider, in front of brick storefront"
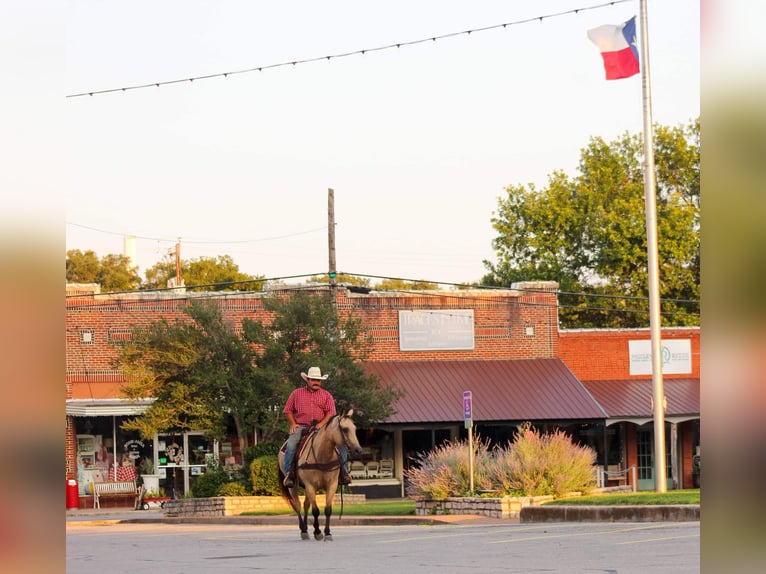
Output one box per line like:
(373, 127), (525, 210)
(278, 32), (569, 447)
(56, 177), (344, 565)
(119, 300), (264, 452)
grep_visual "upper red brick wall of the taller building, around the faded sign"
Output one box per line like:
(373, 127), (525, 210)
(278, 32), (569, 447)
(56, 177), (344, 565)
(66, 283), (559, 397)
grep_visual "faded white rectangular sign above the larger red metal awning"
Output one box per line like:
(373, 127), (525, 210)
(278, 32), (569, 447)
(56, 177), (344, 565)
(399, 309), (474, 351)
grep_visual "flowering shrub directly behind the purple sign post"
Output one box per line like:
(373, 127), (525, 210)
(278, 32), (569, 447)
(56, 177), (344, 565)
(405, 439), (491, 500)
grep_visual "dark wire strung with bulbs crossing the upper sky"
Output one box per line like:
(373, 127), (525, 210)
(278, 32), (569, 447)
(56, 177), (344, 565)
(66, 0), (632, 98)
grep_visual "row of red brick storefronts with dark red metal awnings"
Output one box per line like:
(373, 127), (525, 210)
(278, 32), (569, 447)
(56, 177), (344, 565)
(66, 282), (699, 504)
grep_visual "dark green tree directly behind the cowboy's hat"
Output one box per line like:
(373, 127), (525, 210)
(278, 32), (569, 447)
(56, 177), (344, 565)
(243, 291), (399, 441)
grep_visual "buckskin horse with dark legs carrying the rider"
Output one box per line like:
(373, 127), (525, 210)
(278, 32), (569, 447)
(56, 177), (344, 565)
(278, 409), (362, 541)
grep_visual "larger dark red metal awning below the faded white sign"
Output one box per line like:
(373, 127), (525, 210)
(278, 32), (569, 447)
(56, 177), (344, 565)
(364, 359), (606, 423)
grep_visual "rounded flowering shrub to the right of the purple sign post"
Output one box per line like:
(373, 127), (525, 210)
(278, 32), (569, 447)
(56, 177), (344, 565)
(489, 423), (596, 497)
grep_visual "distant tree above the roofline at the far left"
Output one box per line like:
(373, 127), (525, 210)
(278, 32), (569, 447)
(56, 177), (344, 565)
(66, 249), (141, 291)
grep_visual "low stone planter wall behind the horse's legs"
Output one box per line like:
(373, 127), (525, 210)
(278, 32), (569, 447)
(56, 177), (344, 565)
(164, 494), (367, 517)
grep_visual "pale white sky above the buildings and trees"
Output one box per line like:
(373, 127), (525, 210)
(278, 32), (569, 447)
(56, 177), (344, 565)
(61, 0), (700, 283)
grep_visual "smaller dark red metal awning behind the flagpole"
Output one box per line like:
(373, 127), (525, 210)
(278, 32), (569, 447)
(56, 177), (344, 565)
(583, 378), (700, 418)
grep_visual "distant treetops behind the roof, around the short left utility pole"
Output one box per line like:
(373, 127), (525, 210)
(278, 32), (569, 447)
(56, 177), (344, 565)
(145, 255), (265, 291)
